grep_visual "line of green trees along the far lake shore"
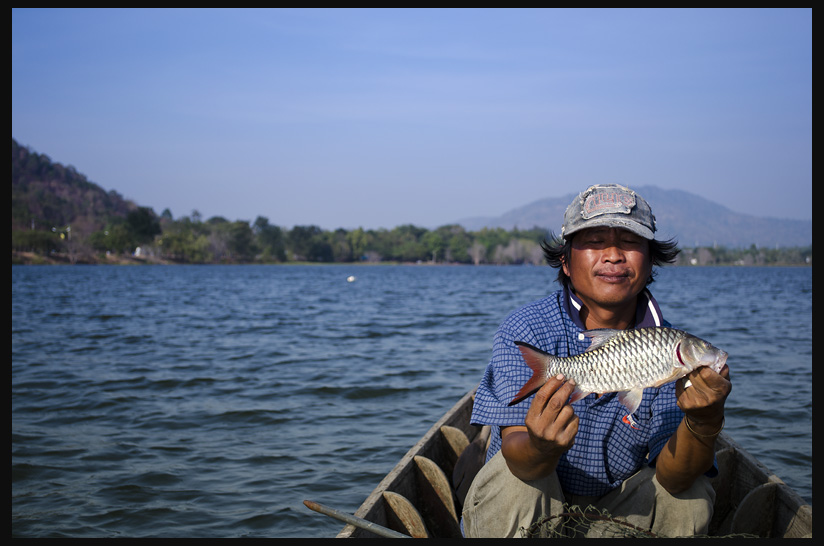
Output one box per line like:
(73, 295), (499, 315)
(12, 207), (812, 265)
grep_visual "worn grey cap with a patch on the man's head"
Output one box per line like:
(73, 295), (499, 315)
(561, 184), (655, 239)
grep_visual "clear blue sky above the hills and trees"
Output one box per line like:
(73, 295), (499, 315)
(12, 9), (812, 229)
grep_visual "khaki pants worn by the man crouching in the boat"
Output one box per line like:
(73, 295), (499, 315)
(463, 452), (715, 538)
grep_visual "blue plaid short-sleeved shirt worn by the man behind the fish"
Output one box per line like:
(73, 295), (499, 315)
(472, 288), (700, 496)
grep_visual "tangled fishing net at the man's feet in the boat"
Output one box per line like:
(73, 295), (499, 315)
(520, 503), (754, 538)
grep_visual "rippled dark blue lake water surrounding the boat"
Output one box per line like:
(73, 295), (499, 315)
(12, 265), (813, 537)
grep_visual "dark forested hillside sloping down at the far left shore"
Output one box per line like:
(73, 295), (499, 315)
(11, 138), (138, 232)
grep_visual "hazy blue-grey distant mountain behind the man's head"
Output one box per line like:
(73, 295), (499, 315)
(457, 186), (813, 248)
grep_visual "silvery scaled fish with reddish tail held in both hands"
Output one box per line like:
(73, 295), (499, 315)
(509, 326), (729, 414)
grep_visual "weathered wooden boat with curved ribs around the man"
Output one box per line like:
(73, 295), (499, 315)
(330, 390), (812, 538)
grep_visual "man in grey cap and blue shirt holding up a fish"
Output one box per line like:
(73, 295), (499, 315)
(461, 184), (731, 537)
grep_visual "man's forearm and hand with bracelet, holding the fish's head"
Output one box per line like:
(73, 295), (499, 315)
(655, 365), (732, 494)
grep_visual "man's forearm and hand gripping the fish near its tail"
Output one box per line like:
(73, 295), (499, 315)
(501, 377), (578, 481)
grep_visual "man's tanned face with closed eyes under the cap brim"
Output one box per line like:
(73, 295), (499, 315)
(563, 227), (652, 310)
